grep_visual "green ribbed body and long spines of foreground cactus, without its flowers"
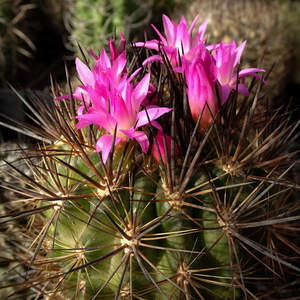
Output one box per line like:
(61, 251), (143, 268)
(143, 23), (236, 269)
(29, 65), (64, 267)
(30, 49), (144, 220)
(0, 19), (300, 300)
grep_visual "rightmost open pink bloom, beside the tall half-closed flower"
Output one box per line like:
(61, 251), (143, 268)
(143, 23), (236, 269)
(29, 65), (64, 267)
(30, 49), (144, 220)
(207, 41), (266, 104)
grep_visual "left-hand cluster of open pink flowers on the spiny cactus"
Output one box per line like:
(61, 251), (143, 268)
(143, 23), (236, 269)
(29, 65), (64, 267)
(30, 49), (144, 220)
(56, 35), (171, 163)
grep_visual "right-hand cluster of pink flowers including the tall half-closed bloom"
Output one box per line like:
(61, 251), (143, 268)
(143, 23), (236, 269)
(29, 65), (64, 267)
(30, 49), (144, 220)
(135, 15), (265, 129)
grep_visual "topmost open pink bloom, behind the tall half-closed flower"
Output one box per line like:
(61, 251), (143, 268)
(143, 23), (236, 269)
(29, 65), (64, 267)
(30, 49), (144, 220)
(135, 15), (208, 67)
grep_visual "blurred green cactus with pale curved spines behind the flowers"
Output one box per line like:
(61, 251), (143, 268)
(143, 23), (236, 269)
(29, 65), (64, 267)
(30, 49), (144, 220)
(64, 0), (153, 56)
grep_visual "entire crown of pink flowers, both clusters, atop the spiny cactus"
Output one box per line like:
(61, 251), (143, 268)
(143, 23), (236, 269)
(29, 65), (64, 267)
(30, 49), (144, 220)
(57, 15), (264, 163)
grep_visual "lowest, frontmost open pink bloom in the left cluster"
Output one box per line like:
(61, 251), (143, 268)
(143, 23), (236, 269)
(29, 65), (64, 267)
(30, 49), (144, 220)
(76, 74), (171, 163)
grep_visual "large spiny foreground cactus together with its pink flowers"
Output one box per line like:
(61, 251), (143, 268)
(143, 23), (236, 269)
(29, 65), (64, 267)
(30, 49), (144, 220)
(1, 12), (300, 299)
